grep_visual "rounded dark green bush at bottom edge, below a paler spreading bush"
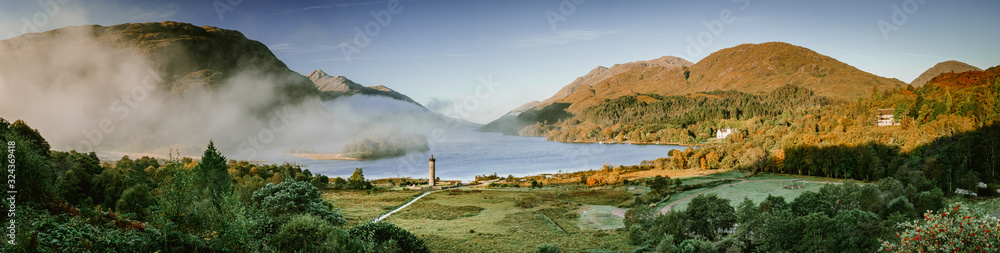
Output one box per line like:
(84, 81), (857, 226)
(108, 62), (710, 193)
(273, 214), (350, 252)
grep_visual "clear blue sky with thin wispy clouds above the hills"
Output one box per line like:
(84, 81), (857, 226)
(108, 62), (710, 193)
(0, 0), (1000, 123)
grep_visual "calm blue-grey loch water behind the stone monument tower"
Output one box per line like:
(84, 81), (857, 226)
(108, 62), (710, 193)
(286, 130), (684, 181)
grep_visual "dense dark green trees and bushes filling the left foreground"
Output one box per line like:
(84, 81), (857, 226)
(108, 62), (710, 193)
(0, 119), (427, 252)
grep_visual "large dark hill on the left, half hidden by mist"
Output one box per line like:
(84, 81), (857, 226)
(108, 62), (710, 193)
(0, 21), (323, 153)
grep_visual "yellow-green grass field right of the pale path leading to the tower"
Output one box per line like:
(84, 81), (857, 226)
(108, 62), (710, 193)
(378, 187), (632, 252)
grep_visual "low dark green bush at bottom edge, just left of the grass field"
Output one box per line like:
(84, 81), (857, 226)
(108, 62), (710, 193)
(348, 222), (430, 252)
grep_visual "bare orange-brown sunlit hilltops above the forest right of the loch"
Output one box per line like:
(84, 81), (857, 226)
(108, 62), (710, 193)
(480, 42), (906, 134)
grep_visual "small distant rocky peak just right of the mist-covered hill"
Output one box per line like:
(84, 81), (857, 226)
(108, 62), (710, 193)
(307, 69), (424, 107)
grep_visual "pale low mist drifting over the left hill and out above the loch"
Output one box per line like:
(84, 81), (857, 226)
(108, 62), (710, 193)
(0, 23), (458, 160)
